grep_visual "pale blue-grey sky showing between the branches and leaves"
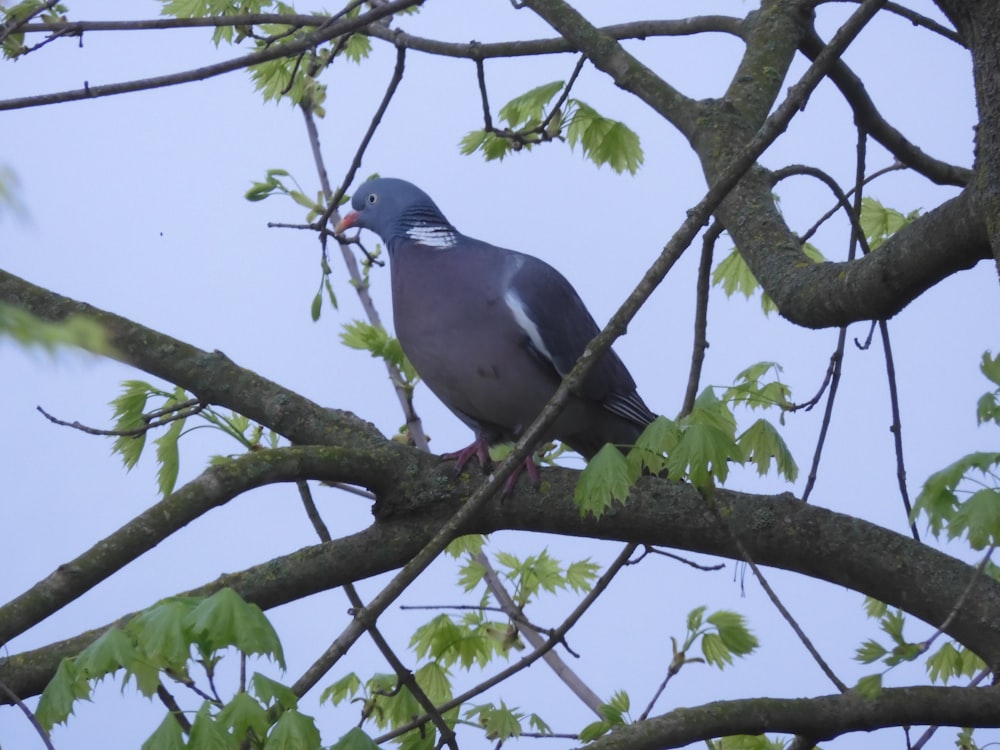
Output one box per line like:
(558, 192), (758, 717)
(0, 0), (1000, 750)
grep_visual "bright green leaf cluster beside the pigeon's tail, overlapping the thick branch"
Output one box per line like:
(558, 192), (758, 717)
(574, 362), (798, 517)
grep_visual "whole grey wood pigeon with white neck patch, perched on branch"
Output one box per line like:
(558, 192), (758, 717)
(336, 178), (656, 489)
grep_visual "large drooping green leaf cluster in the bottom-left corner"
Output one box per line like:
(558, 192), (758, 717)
(36, 589), (320, 750)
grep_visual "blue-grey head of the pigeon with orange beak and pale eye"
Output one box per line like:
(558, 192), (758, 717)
(336, 177), (454, 245)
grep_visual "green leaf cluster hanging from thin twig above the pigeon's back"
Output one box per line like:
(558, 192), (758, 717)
(459, 81), (644, 174)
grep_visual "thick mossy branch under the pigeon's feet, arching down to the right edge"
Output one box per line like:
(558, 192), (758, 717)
(0, 464), (1000, 698)
